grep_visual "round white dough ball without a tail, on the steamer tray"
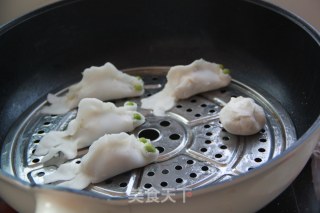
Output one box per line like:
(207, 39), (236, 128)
(220, 96), (266, 135)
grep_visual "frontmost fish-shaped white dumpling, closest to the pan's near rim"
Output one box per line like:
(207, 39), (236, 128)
(44, 133), (159, 189)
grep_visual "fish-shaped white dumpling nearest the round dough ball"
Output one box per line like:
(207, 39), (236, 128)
(141, 59), (231, 116)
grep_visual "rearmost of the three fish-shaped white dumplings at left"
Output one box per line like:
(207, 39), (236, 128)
(41, 62), (144, 114)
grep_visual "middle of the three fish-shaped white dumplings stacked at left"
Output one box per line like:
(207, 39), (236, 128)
(34, 98), (145, 162)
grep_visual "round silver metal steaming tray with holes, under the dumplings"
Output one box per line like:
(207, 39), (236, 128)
(1, 67), (296, 198)
